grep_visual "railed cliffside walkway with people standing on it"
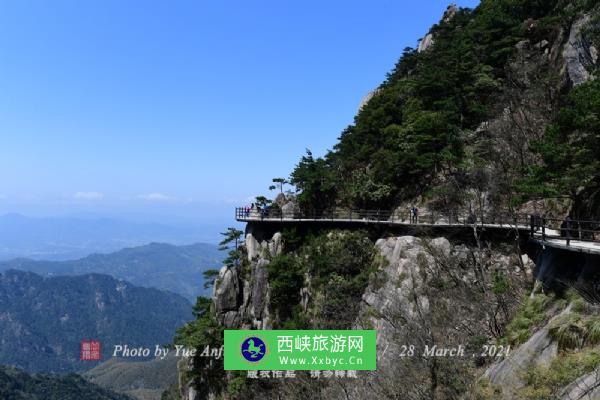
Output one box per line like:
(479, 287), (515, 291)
(235, 207), (600, 255)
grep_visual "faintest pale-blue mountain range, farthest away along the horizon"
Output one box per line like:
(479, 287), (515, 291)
(0, 214), (223, 261)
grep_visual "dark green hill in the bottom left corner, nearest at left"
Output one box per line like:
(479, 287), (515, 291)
(0, 366), (131, 400)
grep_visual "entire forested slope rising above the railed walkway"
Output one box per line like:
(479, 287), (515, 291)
(291, 0), (600, 218)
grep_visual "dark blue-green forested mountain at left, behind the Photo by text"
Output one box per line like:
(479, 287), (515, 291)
(0, 270), (192, 372)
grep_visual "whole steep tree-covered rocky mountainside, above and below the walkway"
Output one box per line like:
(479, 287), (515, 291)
(176, 0), (600, 400)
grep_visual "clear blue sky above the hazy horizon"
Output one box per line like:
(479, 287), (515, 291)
(0, 0), (478, 223)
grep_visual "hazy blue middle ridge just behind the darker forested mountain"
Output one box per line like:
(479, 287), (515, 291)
(0, 243), (224, 303)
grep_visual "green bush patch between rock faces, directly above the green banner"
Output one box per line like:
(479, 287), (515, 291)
(268, 231), (377, 329)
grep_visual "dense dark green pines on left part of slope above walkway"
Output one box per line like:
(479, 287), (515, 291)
(291, 0), (576, 210)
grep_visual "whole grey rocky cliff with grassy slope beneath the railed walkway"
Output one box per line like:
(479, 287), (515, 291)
(176, 231), (600, 400)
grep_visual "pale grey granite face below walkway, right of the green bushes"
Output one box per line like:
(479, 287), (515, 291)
(318, 236), (534, 399)
